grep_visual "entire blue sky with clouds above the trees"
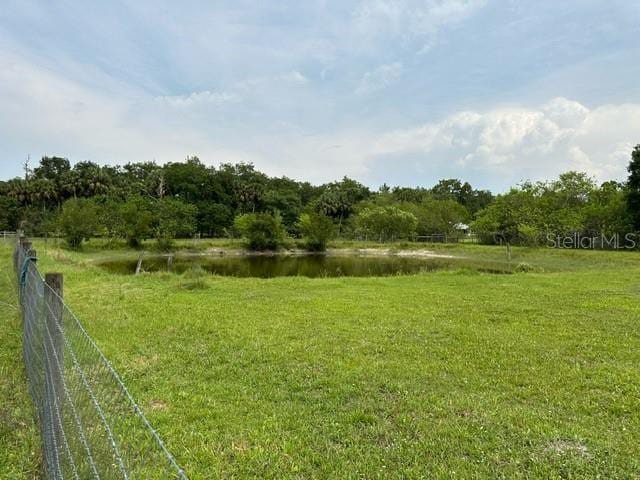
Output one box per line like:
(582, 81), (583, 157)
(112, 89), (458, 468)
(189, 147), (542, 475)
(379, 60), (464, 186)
(0, 0), (640, 192)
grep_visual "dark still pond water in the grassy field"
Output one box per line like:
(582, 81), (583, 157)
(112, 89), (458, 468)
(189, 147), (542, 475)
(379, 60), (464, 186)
(100, 255), (508, 278)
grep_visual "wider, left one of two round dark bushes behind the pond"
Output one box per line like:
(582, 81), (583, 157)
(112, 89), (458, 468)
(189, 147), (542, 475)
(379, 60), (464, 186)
(234, 213), (286, 250)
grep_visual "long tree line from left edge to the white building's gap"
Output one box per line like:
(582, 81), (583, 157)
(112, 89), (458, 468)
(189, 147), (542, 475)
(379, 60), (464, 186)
(0, 157), (493, 249)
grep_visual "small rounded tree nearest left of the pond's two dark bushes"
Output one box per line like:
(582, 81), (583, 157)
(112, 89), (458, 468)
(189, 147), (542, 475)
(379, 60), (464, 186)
(153, 197), (197, 250)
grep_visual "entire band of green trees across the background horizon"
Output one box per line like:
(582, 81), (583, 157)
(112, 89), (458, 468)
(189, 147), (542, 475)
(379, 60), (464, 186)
(0, 145), (640, 250)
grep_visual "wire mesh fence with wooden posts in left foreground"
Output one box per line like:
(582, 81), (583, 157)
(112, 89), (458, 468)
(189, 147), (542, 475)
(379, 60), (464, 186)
(13, 240), (187, 480)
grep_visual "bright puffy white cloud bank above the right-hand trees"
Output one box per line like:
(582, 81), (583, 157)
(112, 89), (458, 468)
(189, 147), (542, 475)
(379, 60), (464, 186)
(369, 98), (640, 183)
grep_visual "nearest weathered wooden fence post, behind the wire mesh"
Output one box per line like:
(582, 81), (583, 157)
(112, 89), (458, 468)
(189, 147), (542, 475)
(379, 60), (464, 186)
(44, 273), (64, 473)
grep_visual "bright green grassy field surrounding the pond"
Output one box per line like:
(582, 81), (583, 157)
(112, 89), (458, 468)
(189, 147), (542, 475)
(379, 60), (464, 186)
(0, 243), (640, 479)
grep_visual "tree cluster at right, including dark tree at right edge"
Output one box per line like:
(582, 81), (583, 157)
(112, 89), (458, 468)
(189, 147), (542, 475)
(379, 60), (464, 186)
(472, 145), (640, 246)
